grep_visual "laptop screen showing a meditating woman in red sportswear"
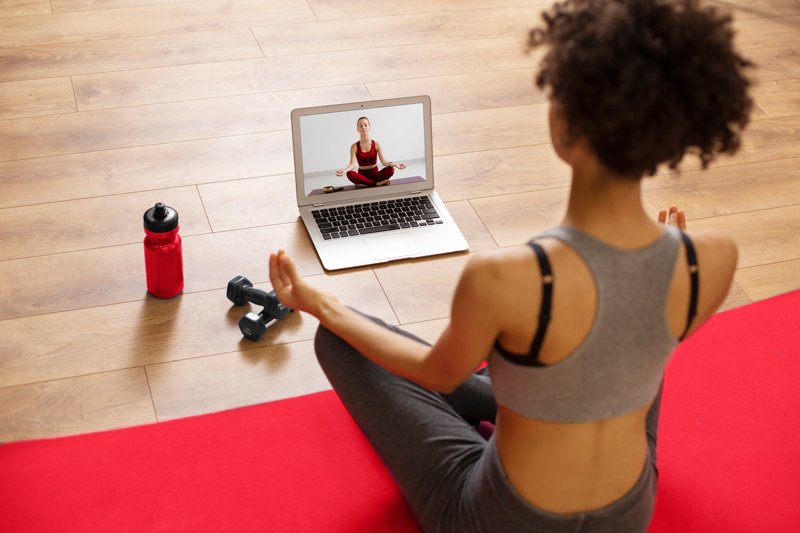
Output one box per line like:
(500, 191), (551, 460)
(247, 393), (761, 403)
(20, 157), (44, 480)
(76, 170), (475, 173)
(292, 97), (432, 205)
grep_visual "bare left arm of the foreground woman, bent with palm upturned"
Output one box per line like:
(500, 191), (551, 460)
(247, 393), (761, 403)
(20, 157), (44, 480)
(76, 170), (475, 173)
(269, 251), (501, 392)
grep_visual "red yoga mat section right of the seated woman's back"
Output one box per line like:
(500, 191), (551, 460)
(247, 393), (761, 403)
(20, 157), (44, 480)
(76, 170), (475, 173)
(650, 291), (800, 533)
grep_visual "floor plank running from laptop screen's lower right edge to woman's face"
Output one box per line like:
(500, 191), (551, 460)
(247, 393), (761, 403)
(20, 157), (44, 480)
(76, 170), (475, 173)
(434, 144), (570, 203)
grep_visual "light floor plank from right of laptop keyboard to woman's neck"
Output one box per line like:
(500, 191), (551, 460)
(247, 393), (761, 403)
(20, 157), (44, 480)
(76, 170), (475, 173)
(470, 187), (569, 248)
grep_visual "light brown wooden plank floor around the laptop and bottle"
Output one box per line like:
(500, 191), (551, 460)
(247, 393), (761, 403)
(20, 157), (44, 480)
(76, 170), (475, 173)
(0, 0), (800, 441)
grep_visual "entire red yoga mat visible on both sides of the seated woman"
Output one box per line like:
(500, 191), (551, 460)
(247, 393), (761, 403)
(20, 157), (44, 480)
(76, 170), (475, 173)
(0, 292), (800, 533)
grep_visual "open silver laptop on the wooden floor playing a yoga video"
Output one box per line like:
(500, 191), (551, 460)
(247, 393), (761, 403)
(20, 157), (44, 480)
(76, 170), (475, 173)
(292, 96), (469, 270)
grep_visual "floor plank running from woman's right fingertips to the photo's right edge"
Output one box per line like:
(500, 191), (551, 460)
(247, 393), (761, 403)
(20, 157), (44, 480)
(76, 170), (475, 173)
(692, 204), (800, 268)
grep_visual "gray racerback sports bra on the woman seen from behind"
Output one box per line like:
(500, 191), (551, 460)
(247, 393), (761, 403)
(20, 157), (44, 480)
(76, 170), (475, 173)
(488, 222), (698, 422)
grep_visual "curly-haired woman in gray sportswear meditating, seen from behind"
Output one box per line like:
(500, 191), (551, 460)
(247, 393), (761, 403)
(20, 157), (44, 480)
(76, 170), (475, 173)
(270, 0), (752, 533)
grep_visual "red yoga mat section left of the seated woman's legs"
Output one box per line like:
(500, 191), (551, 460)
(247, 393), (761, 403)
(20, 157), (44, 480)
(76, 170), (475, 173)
(0, 391), (419, 533)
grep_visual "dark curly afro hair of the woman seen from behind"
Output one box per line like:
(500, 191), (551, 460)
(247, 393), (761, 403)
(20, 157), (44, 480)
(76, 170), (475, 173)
(529, 0), (752, 179)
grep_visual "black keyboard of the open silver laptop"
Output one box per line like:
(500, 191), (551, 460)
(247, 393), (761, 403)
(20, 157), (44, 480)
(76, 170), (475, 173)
(311, 196), (443, 240)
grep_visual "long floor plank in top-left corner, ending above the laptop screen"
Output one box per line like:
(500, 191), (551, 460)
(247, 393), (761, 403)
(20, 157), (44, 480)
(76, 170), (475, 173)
(0, 0), (314, 48)
